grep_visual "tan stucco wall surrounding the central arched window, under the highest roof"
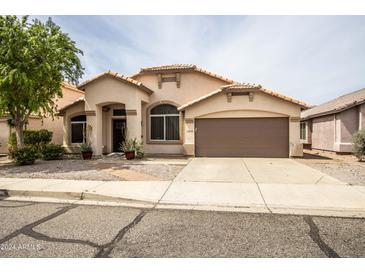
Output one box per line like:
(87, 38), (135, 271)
(135, 72), (227, 154)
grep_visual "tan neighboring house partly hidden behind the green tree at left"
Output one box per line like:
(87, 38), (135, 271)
(0, 83), (84, 153)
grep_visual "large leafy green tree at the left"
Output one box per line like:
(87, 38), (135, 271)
(0, 16), (83, 147)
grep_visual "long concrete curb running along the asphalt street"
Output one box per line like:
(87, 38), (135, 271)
(0, 189), (365, 218)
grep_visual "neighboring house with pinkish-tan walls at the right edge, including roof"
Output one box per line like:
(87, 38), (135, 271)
(300, 89), (365, 153)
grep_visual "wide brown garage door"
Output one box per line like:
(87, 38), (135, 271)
(195, 118), (289, 157)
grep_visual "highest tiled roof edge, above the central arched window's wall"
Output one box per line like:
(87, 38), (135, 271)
(131, 64), (236, 84)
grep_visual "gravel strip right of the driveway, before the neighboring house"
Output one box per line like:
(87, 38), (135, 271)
(296, 151), (365, 185)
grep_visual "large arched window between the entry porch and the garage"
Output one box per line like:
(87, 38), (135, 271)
(150, 104), (180, 141)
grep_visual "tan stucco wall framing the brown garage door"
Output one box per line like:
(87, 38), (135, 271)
(184, 92), (303, 156)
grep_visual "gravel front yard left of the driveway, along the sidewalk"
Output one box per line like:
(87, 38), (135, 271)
(0, 156), (185, 181)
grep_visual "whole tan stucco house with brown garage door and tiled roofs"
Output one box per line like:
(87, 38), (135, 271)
(59, 65), (307, 157)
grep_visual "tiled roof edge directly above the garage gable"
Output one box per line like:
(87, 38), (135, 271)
(178, 83), (308, 111)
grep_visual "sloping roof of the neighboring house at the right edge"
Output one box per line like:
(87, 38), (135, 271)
(301, 88), (365, 120)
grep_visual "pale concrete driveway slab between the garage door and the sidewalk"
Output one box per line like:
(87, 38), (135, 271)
(174, 158), (345, 184)
